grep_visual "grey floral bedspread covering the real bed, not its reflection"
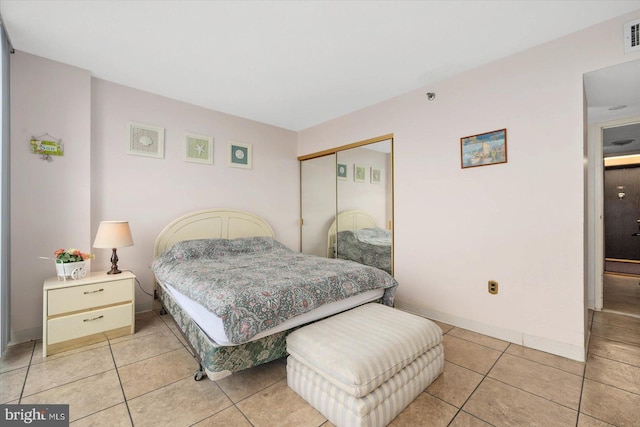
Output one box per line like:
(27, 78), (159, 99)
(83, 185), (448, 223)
(151, 237), (398, 344)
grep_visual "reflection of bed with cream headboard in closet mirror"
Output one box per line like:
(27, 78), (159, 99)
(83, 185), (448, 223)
(327, 210), (392, 273)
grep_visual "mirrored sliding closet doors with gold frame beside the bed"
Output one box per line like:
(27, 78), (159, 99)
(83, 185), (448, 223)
(300, 135), (393, 273)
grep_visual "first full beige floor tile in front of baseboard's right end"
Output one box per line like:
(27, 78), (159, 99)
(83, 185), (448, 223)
(489, 354), (582, 410)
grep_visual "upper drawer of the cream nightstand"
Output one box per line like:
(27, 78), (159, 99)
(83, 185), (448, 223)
(47, 279), (132, 316)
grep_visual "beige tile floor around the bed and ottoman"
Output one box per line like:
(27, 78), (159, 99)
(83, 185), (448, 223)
(0, 312), (640, 427)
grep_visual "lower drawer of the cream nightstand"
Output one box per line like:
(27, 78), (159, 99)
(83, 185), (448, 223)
(47, 304), (133, 345)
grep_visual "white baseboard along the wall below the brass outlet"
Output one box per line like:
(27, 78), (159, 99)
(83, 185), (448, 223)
(395, 300), (586, 362)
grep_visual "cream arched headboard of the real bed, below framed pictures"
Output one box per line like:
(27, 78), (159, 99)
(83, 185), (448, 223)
(153, 209), (275, 258)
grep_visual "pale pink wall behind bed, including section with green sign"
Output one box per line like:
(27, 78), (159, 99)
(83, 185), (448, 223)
(11, 52), (299, 342)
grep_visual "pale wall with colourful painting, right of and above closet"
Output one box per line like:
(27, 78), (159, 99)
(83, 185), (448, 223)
(298, 11), (640, 360)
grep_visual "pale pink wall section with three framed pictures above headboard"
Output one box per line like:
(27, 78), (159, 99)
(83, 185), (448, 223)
(91, 79), (300, 311)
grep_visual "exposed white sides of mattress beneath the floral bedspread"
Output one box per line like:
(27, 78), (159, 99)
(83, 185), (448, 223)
(163, 284), (384, 346)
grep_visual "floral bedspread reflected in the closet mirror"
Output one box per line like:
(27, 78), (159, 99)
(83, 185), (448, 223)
(338, 228), (391, 273)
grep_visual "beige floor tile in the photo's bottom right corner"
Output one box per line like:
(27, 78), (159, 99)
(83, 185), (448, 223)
(580, 379), (640, 426)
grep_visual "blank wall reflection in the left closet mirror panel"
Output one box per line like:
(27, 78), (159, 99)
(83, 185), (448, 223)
(300, 154), (336, 257)
